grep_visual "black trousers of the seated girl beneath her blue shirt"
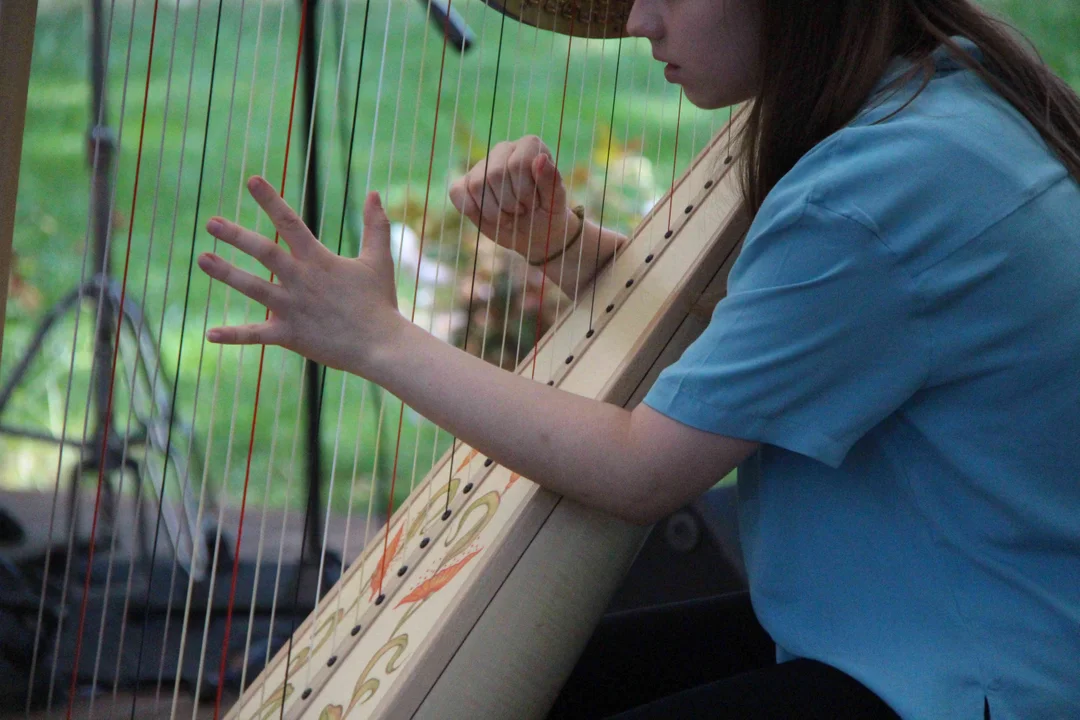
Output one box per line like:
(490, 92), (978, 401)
(549, 593), (897, 720)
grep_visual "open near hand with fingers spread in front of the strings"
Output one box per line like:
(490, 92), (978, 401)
(199, 177), (407, 375)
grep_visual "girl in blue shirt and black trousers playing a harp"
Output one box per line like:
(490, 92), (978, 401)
(199, 0), (1080, 719)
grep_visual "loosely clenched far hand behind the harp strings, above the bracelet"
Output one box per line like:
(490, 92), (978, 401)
(449, 135), (581, 263)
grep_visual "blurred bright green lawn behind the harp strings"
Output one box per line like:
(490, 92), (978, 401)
(0, 0), (1080, 528)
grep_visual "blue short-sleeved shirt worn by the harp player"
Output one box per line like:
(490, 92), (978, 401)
(645, 43), (1080, 720)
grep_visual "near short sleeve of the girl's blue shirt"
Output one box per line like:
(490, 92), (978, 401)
(644, 201), (930, 467)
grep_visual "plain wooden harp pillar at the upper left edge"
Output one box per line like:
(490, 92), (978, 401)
(0, 0), (38, 369)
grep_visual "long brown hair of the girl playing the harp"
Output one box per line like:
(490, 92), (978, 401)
(740, 0), (1080, 214)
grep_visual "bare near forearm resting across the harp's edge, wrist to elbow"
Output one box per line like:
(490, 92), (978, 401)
(363, 323), (654, 522)
